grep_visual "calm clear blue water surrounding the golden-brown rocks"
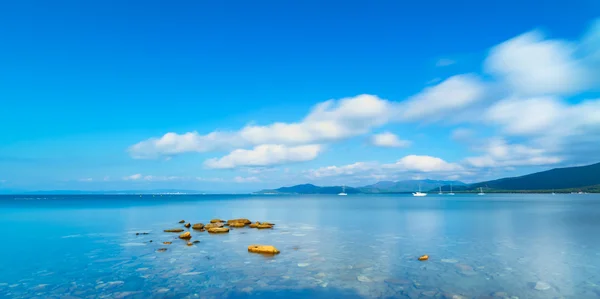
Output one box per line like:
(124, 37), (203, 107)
(0, 194), (600, 299)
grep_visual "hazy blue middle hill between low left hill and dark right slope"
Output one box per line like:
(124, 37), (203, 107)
(359, 180), (466, 193)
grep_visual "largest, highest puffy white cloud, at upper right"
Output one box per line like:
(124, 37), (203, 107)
(485, 31), (591, 96)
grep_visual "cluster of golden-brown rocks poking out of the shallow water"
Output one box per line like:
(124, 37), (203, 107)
(158, 218), (280, 254)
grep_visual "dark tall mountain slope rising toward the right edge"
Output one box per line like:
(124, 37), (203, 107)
(444, 163), (600, 192)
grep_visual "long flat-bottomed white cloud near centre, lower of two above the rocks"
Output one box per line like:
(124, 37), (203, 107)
(204, 144), (322, 169)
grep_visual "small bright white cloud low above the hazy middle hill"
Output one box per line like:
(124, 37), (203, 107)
(382, 155), (463, 172)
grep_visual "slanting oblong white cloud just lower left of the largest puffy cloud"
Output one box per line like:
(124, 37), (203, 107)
(399, 74), (485, 121)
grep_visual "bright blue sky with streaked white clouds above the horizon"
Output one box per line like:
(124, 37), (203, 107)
(0, 0), (600, 192)
